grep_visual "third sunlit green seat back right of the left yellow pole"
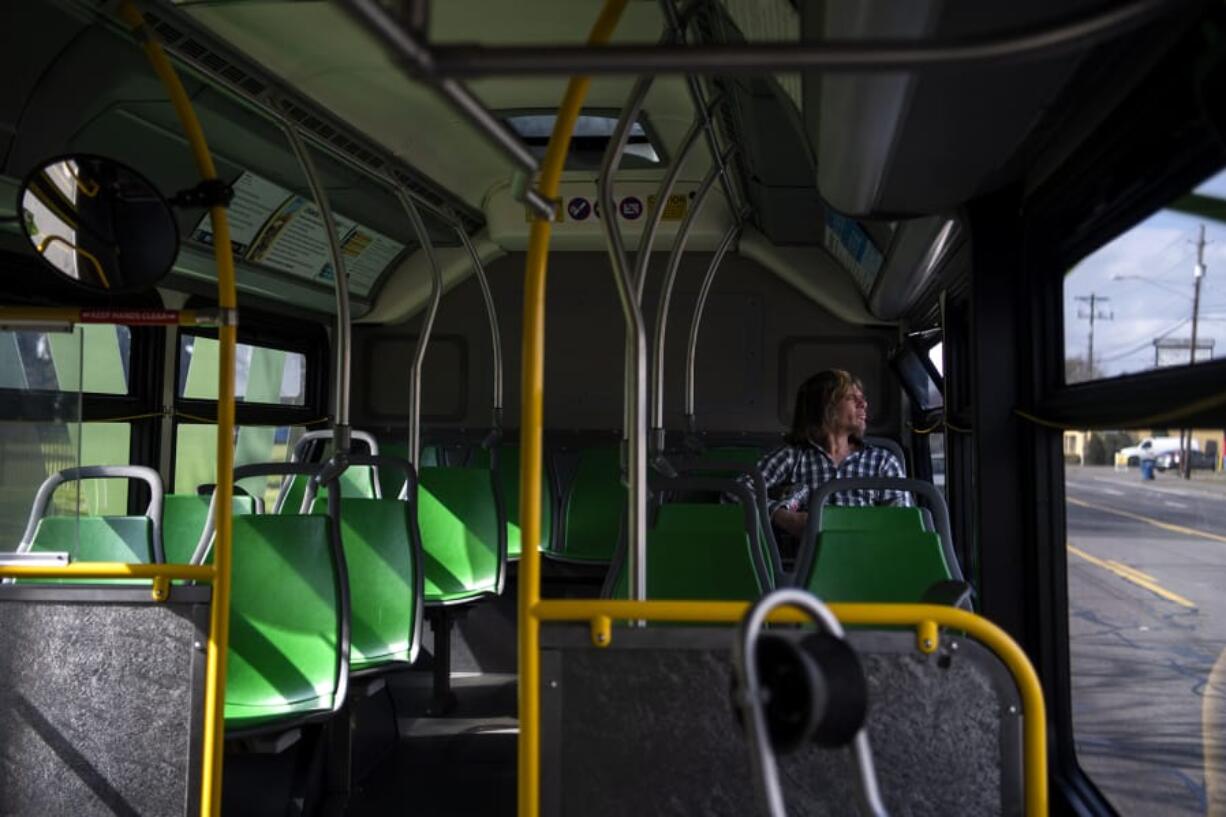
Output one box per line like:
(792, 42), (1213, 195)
(417, 466), (503, 604)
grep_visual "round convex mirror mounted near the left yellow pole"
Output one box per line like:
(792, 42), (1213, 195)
(17, 156), (179, 292)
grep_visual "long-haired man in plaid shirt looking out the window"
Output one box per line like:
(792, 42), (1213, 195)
(758, 369), (911, 537)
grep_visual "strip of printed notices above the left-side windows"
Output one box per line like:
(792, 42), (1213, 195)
(191, 172), (405, 296)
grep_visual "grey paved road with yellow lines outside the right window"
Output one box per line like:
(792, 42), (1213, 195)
(1067, 466), (1226, 815)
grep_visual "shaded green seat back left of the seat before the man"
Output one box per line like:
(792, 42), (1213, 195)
(613, 503), (765, 601)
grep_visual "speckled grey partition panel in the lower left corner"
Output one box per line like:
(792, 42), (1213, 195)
(0, 586), (207, 817)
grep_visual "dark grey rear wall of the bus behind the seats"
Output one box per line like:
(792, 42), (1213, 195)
(353, 253), (901, 435)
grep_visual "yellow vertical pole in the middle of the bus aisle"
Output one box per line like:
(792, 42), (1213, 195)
(519, 0), (626, 817)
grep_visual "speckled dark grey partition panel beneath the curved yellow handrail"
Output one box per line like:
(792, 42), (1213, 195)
(541, 626), (1022, 817)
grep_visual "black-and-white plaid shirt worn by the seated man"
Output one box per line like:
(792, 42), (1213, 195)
(758, 443), (912, 514)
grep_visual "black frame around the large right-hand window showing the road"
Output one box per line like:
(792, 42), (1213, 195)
(1020, 49), (1226, 813)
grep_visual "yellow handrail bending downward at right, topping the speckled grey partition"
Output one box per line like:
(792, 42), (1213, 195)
(532, 588), (1048, 817)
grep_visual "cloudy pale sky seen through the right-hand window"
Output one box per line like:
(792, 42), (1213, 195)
(1064, 171), (1226, 375)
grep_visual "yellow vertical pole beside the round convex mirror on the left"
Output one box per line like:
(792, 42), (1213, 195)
(119, 0), (238, 817)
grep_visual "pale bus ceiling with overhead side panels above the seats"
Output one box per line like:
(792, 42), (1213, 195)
(0, 0), (1176, 323)
